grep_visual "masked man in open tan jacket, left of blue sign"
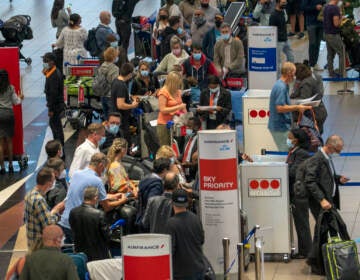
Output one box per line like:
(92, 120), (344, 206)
(214, 22), (245, 77)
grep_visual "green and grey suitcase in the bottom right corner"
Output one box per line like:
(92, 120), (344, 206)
(322, 234), (360, 280)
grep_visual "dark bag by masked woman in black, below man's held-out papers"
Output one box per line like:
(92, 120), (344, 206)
(296, 109), (323, 152)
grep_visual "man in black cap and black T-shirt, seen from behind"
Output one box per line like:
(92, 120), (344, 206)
(166, 189), (205, 280)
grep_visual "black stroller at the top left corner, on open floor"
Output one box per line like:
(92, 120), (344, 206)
(0, 15), (33, 65)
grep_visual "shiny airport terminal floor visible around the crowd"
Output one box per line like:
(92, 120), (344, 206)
(0, 0), (360, 280)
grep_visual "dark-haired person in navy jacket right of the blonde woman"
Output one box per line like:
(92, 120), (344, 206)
(136, 158), (171, 230)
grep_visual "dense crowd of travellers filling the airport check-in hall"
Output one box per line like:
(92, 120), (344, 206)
(0, 0), (358, 279)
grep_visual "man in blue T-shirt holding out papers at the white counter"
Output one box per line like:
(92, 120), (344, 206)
(268, 62), (312, 152)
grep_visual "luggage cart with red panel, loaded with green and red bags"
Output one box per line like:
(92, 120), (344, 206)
(64, 64), (102, 129)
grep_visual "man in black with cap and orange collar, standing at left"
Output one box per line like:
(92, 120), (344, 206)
(43, 52), (65, 147)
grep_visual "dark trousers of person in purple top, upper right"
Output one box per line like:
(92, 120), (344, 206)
(325, 34), (345, 76)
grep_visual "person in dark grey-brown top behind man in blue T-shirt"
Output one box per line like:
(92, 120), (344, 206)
(290, 63), (327, 134)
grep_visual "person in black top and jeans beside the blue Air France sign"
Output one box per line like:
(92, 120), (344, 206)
(269, 0), (294, 76)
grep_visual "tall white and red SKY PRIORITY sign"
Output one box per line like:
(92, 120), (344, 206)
(198, 130), (240, 274)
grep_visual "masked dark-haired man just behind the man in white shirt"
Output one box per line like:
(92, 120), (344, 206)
(100, 112), (123, 154)
